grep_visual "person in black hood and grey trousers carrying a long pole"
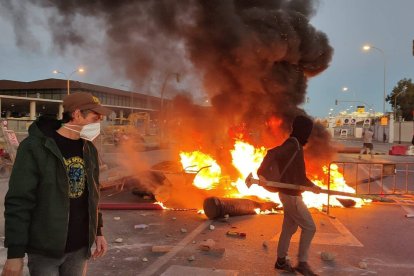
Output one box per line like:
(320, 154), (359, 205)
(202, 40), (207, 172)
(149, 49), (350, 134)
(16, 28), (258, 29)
(257, 115), (320, 275)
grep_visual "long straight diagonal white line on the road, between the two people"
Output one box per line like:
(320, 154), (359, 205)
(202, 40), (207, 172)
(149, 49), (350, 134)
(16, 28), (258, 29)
(139, 220), (211, 276)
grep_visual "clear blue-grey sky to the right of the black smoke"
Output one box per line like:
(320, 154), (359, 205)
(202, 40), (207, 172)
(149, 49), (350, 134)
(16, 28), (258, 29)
(304, 0), (414, 116)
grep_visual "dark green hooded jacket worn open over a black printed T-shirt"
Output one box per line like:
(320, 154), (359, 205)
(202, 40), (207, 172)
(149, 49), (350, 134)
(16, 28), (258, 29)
(4, 118), (102, 259)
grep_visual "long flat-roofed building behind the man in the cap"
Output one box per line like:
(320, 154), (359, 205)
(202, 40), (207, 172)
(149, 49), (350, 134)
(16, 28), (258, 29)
(0, 79), (162, 132)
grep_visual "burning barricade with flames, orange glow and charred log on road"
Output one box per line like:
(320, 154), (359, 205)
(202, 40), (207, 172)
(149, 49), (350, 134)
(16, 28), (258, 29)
(114, 141), (372, 219)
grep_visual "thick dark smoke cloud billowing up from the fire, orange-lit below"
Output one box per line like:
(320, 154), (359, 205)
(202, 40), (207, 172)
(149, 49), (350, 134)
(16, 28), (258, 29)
(1, 0), (333, 176)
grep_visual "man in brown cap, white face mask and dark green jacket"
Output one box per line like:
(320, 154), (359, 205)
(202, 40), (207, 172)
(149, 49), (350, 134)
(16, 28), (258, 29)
(2, 92), (111, 276)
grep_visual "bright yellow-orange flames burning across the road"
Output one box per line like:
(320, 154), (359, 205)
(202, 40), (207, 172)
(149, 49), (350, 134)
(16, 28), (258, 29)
(180, 140), (364, 209)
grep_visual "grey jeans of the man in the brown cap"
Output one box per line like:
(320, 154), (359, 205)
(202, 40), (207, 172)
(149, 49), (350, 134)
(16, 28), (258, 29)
(27, 247), (88, 276)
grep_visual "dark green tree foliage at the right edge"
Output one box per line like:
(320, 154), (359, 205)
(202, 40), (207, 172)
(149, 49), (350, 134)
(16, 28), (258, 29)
(385, 78), (414, 121)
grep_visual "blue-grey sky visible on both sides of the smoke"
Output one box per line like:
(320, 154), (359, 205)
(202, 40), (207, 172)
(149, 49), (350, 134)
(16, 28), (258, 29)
(0, 0), (414, 117)
